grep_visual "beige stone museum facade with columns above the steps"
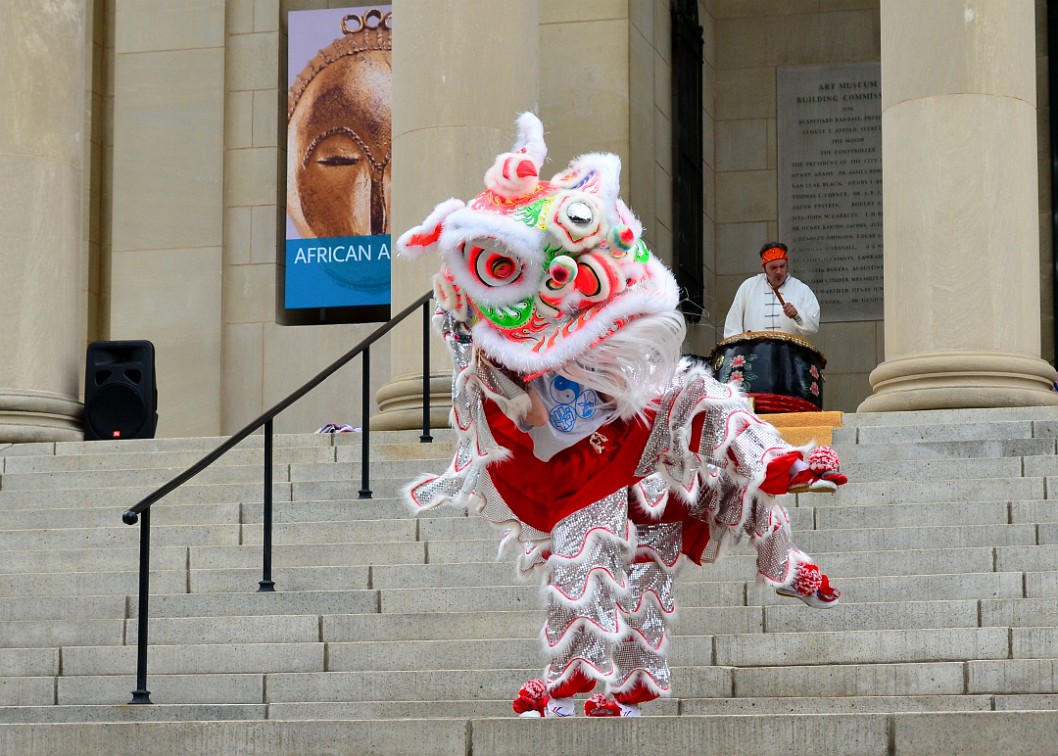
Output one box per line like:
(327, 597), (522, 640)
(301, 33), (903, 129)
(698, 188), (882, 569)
(0, 0), (1058, 442)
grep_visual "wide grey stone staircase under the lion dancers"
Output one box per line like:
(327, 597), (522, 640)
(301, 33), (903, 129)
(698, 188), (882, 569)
(0, 408), (1058, 756)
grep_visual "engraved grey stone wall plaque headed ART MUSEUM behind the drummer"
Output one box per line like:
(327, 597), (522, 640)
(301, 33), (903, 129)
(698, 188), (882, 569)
(777, 62), (882, 320)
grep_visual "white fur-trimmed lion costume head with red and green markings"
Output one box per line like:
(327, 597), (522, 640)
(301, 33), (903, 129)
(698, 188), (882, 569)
(397, 113), (678, 373)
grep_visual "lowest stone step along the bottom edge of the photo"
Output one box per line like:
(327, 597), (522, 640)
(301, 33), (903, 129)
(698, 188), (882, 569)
(5, 712), (1058, 756)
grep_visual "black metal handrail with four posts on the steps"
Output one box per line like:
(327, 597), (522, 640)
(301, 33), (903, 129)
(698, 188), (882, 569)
(122, 292), (434, 703)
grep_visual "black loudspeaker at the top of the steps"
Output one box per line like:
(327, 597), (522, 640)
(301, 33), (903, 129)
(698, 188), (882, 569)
(85, 342), (158, 441)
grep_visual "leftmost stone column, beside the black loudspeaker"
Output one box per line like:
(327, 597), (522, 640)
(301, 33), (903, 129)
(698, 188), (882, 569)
(0, 0), (90, 443)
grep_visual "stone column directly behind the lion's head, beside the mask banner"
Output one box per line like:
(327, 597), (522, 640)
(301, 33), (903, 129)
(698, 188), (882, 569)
(371, 0), (539, 430)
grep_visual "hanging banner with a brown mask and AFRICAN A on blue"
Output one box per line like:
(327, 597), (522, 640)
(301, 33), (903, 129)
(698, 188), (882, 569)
(284, 5), (393, 312)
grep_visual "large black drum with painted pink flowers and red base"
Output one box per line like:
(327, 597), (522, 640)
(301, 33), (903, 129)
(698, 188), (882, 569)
(709, 331), (826, 412)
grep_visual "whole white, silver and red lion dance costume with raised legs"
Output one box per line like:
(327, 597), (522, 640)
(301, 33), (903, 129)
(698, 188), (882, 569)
(397, 113), (846, 716)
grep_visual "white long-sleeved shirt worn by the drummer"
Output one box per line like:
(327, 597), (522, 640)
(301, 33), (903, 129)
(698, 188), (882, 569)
(724, 273), (819, 338)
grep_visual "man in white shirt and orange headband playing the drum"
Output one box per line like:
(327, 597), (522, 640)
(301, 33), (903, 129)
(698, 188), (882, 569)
(724, 241), (819, 338)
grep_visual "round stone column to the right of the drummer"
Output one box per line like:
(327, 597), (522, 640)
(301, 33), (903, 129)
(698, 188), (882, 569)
(859, 0), (1058, 412)
